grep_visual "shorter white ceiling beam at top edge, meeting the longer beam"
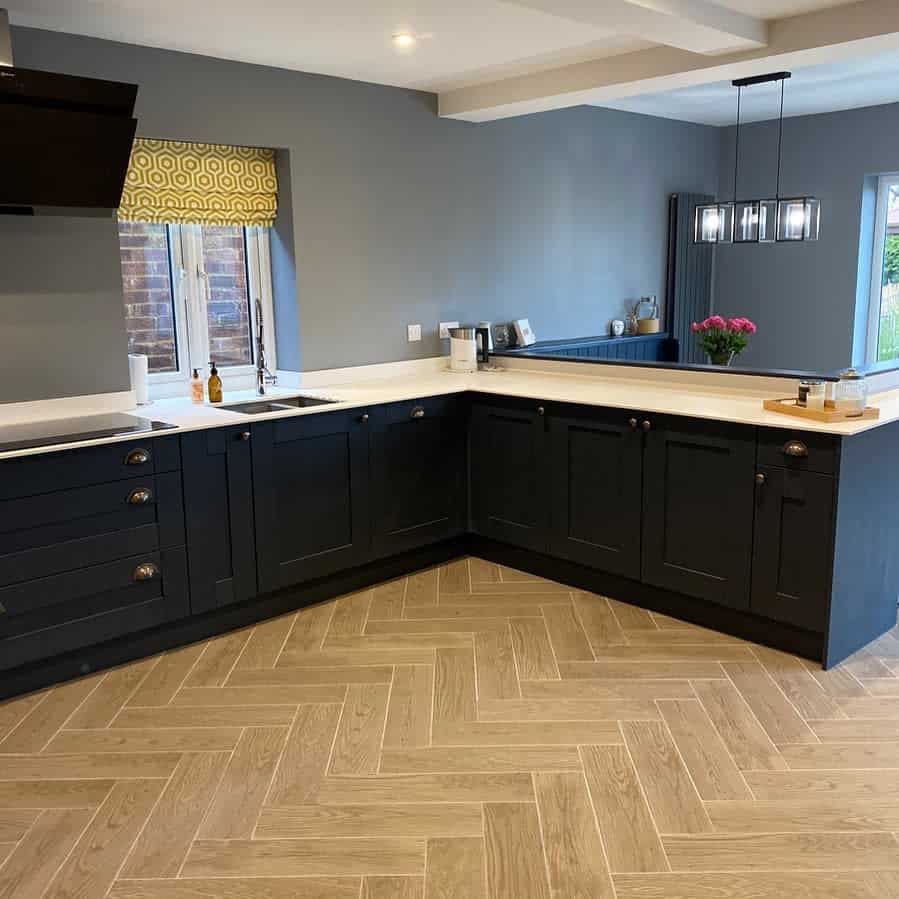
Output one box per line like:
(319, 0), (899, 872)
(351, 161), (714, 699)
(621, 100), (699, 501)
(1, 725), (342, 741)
(505, 0), (768, 53)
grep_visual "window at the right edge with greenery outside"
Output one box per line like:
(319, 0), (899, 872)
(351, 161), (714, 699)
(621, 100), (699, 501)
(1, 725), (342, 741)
(867, 173), (899, 362)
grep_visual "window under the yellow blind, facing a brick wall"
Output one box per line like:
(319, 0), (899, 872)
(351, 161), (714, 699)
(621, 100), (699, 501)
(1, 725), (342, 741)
(119, 222), (275, 396)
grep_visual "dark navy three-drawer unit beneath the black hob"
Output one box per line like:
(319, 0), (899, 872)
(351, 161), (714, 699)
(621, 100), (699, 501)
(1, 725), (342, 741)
(0, 437), (189, 669)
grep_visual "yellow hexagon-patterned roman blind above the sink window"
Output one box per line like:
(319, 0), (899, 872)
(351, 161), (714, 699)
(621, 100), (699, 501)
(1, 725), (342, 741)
(119, 137), (278, 226)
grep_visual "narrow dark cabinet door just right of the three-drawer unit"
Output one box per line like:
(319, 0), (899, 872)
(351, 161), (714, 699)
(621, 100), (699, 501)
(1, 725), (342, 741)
(181, 426), (256, 613)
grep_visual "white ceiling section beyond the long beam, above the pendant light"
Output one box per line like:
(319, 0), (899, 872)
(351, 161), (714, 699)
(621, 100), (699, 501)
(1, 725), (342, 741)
(597, 48), (899, 125)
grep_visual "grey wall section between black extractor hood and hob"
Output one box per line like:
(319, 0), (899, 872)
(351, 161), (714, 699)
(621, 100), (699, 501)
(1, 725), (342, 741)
(0, 216), (130, 403)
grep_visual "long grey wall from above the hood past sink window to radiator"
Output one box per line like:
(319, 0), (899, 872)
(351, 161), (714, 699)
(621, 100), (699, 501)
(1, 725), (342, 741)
(0, 29), (719, 400)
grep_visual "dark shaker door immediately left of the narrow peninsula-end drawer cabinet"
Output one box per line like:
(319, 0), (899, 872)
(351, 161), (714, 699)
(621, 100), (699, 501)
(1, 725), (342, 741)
(643, 416), (755, 608)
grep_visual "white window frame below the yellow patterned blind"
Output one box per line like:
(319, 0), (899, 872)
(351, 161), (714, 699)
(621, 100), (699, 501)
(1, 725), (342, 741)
(130, 225), (277, 399)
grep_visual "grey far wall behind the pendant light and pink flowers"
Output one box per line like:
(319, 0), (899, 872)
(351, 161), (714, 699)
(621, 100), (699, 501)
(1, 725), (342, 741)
(715, 103), (899, 369)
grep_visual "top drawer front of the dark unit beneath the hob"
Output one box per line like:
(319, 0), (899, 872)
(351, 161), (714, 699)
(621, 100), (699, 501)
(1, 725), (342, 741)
(0, 437), (181, 500)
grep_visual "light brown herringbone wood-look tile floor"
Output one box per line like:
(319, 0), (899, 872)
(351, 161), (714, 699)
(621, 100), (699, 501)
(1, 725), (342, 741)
(0, 559), (899, 899)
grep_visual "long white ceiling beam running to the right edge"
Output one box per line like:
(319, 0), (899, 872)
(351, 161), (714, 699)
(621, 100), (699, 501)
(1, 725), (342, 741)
(439, 0), (899, 122)
